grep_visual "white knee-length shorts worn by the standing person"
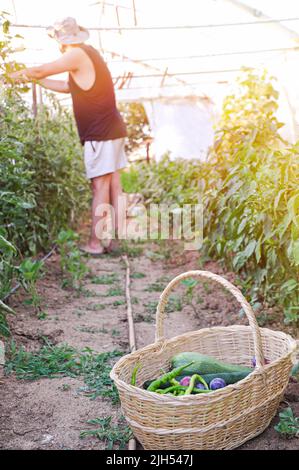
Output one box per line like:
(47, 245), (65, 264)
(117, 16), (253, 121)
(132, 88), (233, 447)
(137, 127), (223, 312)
(84, 138), (127, 179)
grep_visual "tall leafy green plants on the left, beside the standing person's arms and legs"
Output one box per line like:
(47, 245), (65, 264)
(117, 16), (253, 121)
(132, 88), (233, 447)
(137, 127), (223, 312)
(0, 13), (90, 255)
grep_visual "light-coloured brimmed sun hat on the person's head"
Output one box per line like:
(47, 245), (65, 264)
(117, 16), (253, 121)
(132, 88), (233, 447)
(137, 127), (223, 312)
(47, 17), (89, 44)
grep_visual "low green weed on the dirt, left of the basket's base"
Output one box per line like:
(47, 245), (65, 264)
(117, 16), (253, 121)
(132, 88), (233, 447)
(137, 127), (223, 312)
(80, 416), (133, 450)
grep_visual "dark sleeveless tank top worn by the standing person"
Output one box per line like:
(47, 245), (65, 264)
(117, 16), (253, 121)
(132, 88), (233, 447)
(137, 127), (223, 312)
(69, 44), (127, 145)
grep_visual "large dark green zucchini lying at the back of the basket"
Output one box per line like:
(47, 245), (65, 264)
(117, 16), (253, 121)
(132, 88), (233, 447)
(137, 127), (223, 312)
(171, 352), (252, 380)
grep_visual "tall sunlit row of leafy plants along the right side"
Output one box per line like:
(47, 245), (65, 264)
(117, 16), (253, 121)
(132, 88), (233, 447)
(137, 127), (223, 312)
(130, 69), (299, 324)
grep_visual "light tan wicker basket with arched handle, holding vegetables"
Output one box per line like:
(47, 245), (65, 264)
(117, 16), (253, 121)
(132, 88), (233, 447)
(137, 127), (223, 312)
(111, 271), (296, 450)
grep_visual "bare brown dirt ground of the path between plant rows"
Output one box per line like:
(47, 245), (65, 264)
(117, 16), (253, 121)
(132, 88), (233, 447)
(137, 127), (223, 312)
(0, 242), (299, 450)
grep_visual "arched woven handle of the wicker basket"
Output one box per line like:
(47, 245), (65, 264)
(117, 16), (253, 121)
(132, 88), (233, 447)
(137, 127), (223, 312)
(156, 271), (264, 367)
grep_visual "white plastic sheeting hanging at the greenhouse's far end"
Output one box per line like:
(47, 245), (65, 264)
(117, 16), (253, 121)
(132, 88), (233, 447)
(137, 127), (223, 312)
(143, 97), (214, 160)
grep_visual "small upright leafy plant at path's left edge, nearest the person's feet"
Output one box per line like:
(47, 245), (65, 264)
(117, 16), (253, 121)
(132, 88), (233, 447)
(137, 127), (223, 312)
(56, 229), (88, 289)
